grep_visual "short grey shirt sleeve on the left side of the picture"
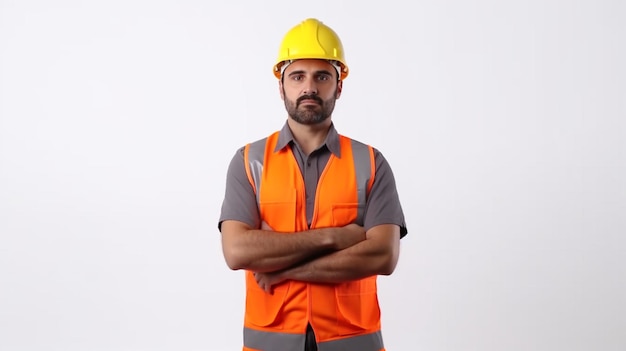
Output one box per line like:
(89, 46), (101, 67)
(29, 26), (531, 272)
(217, 147), (261, 231)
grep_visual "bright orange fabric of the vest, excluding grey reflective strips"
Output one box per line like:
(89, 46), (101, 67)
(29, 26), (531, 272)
(244, 133), (380, 342)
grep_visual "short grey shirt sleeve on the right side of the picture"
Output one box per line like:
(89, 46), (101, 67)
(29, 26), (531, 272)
(364, 149), (408, 238)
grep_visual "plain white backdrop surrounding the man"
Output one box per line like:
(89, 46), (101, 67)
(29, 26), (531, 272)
(0, 0), (626, 351)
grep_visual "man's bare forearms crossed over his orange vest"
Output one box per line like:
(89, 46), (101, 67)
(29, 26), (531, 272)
(221, 220), (400, 291)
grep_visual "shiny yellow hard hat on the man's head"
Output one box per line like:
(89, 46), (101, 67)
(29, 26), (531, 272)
(274, 18), (348, 80)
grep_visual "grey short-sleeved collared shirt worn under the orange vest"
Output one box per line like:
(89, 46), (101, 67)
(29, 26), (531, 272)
(218, 123), (407, 237)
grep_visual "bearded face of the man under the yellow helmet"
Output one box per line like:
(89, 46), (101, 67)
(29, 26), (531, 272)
(280, 60), (342, 125)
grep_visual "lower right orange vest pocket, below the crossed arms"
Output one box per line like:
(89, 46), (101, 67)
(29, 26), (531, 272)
(335, 276), (380, 335)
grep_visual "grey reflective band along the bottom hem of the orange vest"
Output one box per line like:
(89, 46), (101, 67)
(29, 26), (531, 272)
(243, 328), (384, 351)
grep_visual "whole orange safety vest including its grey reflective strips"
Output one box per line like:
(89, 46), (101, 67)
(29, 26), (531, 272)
(243, 132), (384, 351)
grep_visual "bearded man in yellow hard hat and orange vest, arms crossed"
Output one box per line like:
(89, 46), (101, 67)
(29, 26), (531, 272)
(218, 19), (407, 351)
